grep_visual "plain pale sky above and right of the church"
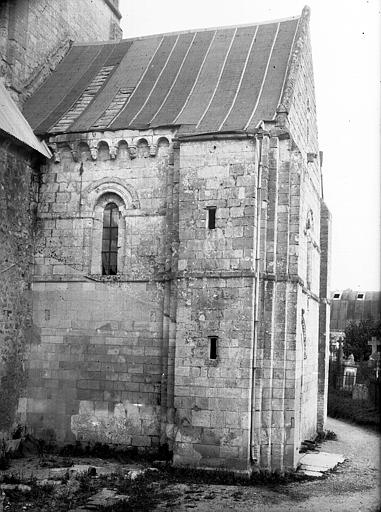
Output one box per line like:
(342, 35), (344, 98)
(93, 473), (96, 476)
(119, 0), (381, 290)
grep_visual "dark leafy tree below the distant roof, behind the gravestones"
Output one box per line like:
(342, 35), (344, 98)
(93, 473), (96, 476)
(343, 319), (381, 361)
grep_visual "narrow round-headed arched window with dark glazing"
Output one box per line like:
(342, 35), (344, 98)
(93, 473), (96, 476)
(102, 203), (119, 276)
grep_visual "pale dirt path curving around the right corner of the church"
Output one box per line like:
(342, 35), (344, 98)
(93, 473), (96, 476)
(156, 419), (381, 512)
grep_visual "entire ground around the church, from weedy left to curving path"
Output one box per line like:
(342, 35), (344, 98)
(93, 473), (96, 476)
(0, 419), (381, 512)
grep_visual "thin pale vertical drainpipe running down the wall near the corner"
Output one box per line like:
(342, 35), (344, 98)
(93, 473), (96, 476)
(249, 132), (263, 463)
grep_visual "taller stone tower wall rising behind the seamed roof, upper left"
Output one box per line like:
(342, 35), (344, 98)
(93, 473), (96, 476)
(0, 0), (121, 102)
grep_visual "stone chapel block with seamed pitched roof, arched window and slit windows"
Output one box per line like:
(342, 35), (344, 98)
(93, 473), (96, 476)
(0, 2), (330, 470)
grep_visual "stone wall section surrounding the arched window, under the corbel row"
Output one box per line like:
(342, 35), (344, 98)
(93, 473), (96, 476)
(19, 132), (177, 448)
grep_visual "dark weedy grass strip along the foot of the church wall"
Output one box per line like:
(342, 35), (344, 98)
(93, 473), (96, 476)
(3, 458), (309, 512)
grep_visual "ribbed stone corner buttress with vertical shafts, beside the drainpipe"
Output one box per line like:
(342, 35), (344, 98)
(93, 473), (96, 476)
(252, 130), (300, 470)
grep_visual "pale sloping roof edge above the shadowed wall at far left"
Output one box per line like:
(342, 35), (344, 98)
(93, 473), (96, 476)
(0, 81), (52, 158)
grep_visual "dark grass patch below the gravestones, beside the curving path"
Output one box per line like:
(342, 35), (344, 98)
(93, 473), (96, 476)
(328, 389), (380, 430)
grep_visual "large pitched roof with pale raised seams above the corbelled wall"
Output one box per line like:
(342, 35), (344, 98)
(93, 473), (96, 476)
(24, 12), (308, 138)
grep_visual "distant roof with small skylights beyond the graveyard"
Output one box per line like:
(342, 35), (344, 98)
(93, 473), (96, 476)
(330, 289), (381, 331)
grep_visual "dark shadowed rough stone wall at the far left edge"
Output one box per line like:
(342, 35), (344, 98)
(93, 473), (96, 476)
(0, 137), (37, 436)
